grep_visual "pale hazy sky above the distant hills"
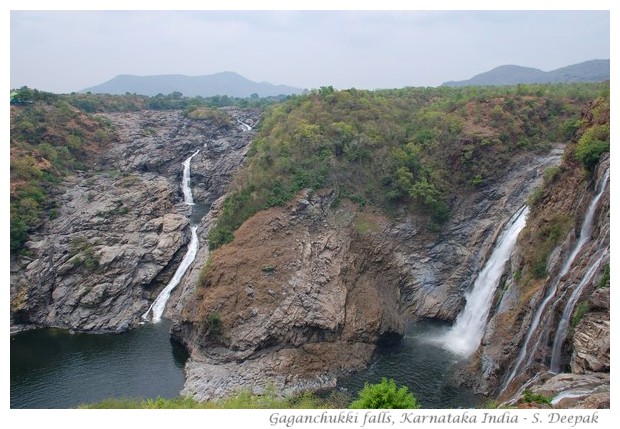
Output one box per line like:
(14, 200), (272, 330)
(10, 11), (610, 92)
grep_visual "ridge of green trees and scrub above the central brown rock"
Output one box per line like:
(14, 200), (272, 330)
(209, 83), (609, 248)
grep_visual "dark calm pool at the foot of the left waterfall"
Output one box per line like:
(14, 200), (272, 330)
(11, 320), (187, 408)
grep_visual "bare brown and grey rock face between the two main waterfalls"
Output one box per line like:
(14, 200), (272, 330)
(169, 148), (561, 399)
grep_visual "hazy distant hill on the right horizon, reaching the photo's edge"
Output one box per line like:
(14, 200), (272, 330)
(442, 60), (610, 86)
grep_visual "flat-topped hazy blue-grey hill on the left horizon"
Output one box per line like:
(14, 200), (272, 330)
(80, 72), (302, 97)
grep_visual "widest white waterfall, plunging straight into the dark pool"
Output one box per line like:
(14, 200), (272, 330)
(439, 206), (529, 356)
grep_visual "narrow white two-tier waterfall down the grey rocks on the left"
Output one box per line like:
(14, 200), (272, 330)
(142, 150), (200, 323)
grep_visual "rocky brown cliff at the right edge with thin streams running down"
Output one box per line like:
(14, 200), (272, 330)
(464, 99), (610, 408)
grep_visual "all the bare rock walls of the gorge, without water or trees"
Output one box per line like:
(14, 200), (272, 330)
(11, 93), (610, 407)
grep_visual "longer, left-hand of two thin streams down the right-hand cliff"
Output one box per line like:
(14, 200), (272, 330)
(502, 170), (609, 389)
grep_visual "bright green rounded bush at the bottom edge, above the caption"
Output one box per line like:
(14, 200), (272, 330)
(349, 378), (420, 409)
